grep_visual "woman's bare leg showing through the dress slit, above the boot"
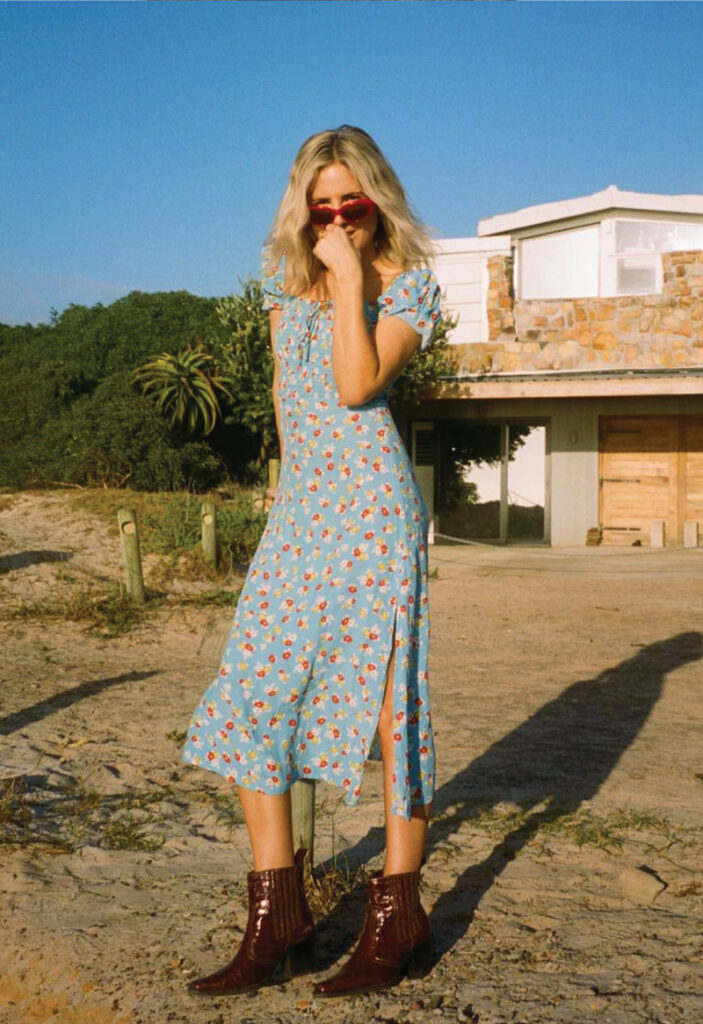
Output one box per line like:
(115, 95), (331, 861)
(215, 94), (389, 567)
(379, 647), (432, 874)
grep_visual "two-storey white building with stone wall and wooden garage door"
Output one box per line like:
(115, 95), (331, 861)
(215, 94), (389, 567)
(409, 185), (703, 546)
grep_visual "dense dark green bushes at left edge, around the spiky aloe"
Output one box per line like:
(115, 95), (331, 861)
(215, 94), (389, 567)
(0, 292), (225, 489)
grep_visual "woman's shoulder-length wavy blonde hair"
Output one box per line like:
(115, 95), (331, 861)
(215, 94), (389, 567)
(264, 125), (434, 295)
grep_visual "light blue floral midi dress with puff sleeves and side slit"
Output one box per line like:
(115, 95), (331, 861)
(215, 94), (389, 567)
(182, 268), (440, 819)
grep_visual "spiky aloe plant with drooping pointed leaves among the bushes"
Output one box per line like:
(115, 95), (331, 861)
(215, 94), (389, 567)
(132, 345), (232, 437)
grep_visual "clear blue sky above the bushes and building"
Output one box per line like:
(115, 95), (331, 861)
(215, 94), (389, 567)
(0, 0), (703, 324)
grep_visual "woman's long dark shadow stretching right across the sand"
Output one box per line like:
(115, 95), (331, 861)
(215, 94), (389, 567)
(315, 632), (703, 955)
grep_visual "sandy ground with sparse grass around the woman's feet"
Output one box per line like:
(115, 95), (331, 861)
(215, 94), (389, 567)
(0, 494), (703, 1024)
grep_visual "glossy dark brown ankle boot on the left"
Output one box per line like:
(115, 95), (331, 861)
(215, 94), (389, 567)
(188, 851), (315, 995)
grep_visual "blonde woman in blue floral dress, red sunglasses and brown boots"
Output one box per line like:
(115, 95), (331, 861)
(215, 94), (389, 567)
(183, 125), (439, 995)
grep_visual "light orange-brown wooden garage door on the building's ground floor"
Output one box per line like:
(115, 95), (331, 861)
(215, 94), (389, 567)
(600, 416), (703, 545)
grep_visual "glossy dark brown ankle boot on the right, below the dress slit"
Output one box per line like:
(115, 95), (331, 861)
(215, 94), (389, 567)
(313, 871), (433, 995)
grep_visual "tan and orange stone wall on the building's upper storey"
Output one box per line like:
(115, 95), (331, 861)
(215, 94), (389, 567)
(457, 252), (703, 374)
